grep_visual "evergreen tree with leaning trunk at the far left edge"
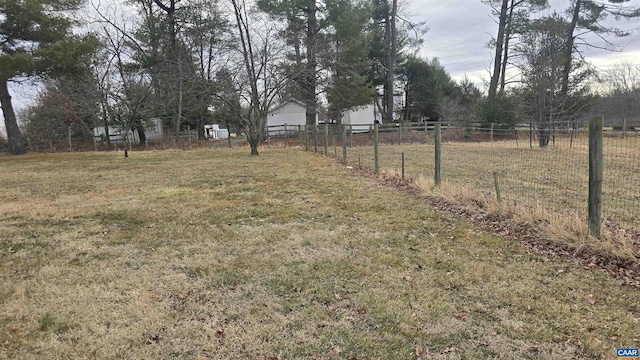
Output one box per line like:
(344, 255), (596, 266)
(0, 0), (96, 155)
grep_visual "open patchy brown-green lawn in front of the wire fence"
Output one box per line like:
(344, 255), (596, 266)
(0, 149), (640, 359)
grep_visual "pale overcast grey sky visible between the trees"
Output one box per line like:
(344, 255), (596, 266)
(0, 0), (640, 135)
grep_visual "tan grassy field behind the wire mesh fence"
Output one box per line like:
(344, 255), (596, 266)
(338, 130), (640, 235)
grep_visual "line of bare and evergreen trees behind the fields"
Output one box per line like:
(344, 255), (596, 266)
(0, 0), (640, 155)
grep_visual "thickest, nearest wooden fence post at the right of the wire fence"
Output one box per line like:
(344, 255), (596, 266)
(588, 116), (603, 239)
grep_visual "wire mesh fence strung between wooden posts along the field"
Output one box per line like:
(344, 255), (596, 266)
(290, 122), (640, 231)
